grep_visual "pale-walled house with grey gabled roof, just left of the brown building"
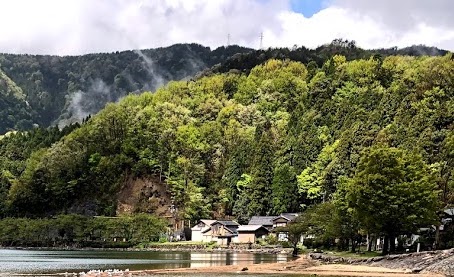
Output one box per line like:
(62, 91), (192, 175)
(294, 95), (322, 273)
(202, 220), (240, 245)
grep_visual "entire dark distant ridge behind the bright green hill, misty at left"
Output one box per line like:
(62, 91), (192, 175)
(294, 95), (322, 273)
(0, 39), (446, 134)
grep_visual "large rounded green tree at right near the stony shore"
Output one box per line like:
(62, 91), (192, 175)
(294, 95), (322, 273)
(347, 146), (439, 254)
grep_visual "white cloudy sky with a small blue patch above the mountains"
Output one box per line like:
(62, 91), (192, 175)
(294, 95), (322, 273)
(0, 0), (454, 55)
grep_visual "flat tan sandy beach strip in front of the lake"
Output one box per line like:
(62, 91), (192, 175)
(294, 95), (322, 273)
(121, 254), (444, 277)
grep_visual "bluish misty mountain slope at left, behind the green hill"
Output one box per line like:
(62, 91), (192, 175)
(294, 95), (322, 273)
(0, 44), (251, 134)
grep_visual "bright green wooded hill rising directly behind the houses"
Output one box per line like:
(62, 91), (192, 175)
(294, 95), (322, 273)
(0, 53), (454, 230)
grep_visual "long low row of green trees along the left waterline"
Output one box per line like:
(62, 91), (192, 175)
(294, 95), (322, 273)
(0, 214), (166, 247)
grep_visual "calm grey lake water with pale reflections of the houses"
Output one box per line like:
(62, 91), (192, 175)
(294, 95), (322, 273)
(0, 250), (288, 276)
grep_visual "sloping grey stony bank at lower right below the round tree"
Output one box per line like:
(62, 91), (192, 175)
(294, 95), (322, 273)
(308, 248), (454, 276)
